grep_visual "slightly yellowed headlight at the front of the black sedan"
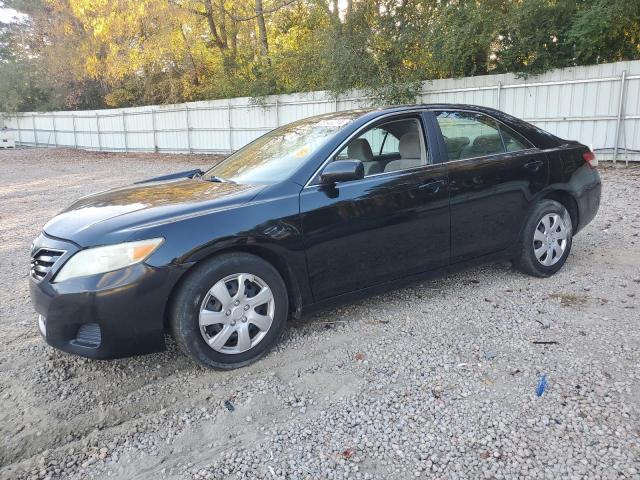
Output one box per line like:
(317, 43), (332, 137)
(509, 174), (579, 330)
(53, 238), (164, 283)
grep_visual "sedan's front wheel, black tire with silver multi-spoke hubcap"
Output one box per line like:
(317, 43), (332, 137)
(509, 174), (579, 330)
(169, 252), (289, 370)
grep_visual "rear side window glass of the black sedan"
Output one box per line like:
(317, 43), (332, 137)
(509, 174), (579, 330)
(435, 110), (531, 160)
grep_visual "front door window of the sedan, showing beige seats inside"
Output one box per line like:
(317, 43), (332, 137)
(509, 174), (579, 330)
(336, 118), (427, 176)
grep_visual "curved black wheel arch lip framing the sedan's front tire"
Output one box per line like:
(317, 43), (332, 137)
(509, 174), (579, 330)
(163, 244), (303, 330)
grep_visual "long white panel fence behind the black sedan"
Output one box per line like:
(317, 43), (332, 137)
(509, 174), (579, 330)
(0, 61), (640, 161)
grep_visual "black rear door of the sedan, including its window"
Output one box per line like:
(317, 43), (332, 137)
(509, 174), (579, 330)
(434, 110), (549, 263)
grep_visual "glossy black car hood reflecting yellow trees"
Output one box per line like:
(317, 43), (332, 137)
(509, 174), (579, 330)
(44, 179), (263, 246)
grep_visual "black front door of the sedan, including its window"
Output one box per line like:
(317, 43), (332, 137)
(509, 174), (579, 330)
(300, 114), (450, 301)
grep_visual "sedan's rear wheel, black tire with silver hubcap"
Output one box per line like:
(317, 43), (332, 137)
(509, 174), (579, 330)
(513, 200), (573, 277)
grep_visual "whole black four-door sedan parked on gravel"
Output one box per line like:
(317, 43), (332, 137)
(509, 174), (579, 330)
(30, 105), (601, 368)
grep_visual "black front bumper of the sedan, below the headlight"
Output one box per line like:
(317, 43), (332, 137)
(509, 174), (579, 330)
(29, 235), (189, 359)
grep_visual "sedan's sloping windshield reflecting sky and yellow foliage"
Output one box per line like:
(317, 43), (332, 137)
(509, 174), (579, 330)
(202, 111), (362, 183)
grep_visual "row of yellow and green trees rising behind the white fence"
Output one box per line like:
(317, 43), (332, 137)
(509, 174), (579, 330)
(0, 0), (640, 110)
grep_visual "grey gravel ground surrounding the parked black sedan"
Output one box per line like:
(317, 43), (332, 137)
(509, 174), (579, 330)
(0, 149), (640, 479)
